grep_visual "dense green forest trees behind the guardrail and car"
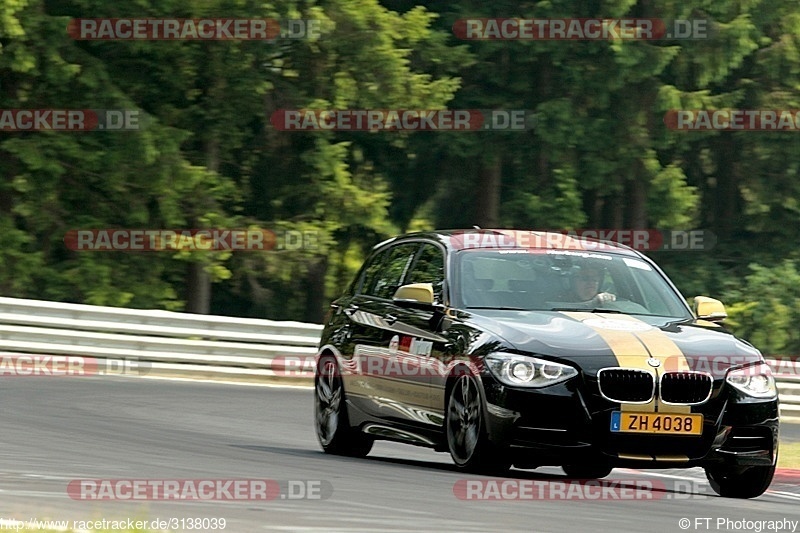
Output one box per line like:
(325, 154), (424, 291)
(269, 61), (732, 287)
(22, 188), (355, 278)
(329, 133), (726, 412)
(0, 0), (800, 350)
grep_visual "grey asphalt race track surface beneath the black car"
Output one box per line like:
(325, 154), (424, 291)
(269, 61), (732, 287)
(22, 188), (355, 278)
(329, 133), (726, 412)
(0, 377), (800, 533)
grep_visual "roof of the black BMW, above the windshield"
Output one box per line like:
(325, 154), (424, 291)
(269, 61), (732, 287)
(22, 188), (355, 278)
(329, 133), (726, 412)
(375, 228), (641, 257)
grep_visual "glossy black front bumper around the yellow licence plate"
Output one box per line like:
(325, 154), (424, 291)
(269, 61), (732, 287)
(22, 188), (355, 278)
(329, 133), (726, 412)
(482, 373), (779, 468)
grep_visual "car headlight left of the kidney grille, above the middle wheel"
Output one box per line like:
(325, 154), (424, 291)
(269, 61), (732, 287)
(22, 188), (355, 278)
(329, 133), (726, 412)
(486, 352), (578, 388)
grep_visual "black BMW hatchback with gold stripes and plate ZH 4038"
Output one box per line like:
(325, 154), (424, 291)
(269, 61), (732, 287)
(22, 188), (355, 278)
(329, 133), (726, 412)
(315, 229), (779, 498)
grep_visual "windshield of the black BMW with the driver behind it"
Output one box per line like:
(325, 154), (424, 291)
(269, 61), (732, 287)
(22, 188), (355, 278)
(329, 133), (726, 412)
(453, 249), (691, 319)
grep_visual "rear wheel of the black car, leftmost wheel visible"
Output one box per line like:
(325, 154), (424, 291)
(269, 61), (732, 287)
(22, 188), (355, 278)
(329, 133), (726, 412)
(314, 355), (374, 457)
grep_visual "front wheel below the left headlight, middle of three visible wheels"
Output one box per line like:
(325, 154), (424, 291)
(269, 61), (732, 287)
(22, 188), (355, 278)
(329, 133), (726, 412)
(445, 375), (511, 474)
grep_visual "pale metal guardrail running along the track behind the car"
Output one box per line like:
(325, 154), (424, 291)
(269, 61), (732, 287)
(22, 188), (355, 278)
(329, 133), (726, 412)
(0, 297), (800, 417)
